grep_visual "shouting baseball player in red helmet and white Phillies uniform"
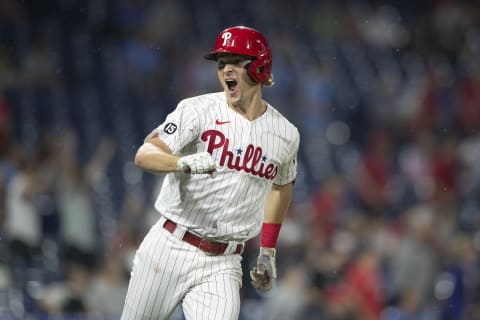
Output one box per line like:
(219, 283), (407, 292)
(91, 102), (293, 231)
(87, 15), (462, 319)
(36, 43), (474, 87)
(122, 26), (300, 320)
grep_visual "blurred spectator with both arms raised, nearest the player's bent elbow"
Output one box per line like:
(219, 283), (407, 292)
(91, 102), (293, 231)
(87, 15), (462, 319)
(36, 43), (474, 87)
(57, 131), (115, 267)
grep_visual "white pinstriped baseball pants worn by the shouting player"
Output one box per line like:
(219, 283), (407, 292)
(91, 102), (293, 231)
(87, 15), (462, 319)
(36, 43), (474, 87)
(121, 222), (242, 320)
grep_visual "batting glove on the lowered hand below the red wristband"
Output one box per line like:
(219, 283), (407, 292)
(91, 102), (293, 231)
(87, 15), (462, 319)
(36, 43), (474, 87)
(250, 247), (277, 291)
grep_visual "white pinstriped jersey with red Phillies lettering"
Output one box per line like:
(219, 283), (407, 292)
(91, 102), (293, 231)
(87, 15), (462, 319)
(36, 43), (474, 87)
(150, 92), (300, 241)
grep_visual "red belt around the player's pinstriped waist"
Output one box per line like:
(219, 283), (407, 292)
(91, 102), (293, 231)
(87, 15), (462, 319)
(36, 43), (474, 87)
(163, 219), (244, 255)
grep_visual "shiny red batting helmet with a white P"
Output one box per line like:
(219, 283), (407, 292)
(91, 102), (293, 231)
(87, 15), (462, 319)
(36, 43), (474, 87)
(205, 26), (272, 82)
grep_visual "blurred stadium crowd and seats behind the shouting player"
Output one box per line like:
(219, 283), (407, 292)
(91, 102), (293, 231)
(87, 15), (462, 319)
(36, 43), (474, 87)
(0, 0), (480, 320)
